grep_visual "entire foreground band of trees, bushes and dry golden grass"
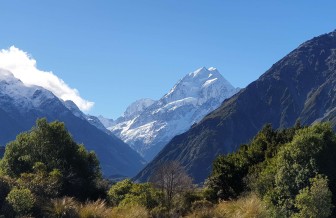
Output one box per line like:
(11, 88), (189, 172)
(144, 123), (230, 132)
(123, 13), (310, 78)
(0, 119), (336, 218)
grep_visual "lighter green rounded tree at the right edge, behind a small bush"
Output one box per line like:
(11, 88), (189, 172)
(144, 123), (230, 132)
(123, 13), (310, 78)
(254, 124), (336, 216)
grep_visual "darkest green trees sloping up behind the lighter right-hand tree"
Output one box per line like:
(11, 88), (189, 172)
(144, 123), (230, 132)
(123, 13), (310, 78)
(206, 124), (301, 201)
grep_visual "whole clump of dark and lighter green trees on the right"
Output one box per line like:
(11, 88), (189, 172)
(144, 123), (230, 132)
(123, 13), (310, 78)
(206, 123), (336, 217)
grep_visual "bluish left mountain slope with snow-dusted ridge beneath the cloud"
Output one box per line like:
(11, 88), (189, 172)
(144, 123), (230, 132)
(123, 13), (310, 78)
(0, 69), (144, 176)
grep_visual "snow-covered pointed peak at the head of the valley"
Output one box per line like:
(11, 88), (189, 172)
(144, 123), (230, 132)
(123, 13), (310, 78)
(108, 67), (239, 160)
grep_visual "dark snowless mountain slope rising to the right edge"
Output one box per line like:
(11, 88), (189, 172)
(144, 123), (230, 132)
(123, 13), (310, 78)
(136, 31), (336, 183)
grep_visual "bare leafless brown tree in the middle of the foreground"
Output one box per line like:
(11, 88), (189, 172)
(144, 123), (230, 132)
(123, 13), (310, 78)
(150, 161), (192, 211)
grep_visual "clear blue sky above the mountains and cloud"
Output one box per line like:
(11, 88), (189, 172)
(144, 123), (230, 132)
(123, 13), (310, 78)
(0, 0), (336, 118)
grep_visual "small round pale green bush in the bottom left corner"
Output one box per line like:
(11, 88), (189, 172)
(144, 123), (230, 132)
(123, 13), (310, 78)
(6, 188), (35, 216)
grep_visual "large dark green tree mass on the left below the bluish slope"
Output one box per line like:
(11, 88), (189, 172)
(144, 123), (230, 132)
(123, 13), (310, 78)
(0, 119), (101, 200)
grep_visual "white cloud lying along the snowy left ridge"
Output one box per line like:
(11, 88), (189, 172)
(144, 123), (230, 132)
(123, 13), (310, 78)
(0, 46), (94, 111)
